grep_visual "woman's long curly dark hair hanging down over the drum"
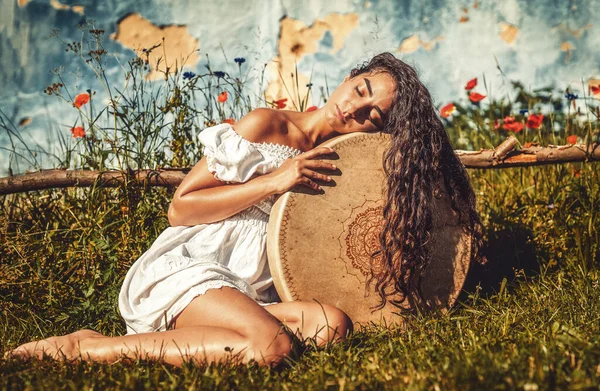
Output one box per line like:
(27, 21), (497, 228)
(350, 53), (485, 311)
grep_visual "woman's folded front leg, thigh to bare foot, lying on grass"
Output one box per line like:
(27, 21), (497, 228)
(7, 288), (292, 365)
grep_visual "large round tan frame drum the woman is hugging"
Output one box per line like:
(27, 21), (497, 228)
(267, 133), (471, 324)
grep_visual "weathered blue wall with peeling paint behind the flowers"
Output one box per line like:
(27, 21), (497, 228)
(0, 0), (600, 172)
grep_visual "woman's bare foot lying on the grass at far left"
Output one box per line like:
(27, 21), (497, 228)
(5, 330), (103, 361)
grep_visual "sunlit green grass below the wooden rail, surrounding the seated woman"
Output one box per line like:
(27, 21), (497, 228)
(0, 164), (600, 390)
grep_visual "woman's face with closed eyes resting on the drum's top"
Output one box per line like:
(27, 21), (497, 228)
(325, 73), (396, 133)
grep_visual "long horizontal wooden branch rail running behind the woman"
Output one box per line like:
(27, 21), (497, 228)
(0, 141), (600, 195)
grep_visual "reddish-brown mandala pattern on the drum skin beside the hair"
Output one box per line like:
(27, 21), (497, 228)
(345, 206), (384, 277)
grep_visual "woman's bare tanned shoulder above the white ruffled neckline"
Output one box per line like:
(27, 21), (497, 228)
(233, 108), (288, 143)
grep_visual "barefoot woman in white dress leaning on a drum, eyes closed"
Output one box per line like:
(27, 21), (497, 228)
(12, 53), (481, 365)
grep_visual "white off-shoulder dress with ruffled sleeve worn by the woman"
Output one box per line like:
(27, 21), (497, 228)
(119, 124), (302, 334)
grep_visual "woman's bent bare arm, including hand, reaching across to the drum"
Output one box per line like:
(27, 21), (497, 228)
(168, 147), (335, 226)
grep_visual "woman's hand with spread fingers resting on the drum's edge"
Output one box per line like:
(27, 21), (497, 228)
(265, 147), (337, 194)
